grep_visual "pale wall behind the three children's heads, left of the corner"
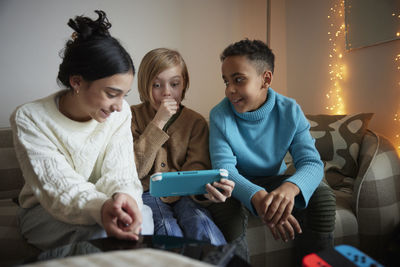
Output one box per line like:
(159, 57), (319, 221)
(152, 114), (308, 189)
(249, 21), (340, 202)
(0, 0), (267, 127)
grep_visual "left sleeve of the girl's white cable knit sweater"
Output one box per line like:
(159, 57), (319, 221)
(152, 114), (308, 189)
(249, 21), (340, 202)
(10, 110), (108, 225)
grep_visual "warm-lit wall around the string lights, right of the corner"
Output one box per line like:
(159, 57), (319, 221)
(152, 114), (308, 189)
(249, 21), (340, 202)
(282, 0), (400, 149)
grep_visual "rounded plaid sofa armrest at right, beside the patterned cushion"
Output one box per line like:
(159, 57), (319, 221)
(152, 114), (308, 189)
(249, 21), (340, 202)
(352, 131), (400, 256)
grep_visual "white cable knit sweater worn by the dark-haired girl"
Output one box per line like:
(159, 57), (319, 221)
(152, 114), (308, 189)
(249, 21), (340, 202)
(10, 94), (143, 225)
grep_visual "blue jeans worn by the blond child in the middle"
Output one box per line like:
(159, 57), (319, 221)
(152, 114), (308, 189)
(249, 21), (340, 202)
(142, 192), (226, 246)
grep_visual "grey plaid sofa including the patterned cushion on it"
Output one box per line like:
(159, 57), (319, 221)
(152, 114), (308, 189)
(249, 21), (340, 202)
(0, 113), (400, 267)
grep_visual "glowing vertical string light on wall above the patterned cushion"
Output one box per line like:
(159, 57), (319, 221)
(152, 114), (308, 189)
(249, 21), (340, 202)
(326, 0), (345, 114)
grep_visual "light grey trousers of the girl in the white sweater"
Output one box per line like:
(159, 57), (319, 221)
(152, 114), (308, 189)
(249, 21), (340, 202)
(17, 205), (153, 250)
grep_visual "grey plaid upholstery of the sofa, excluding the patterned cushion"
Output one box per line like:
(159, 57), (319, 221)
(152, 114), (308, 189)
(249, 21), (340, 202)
(0, 128), (400, 267)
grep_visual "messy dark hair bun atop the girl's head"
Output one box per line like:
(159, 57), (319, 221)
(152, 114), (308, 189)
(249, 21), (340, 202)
(68, 10), (111, 41)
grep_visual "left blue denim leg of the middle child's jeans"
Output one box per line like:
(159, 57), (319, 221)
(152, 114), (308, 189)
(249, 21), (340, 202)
(142, 192), (183, 237)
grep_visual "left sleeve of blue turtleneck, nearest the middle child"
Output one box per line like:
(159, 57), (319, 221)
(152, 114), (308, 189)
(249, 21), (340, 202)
(210, 110), (265, 215)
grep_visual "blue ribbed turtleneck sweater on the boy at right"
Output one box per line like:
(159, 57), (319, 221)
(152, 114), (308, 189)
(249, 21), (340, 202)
(210, 88), (324, 214)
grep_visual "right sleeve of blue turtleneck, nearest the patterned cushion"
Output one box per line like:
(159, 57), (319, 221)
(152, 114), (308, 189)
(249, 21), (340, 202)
(287, 107), (324, 208)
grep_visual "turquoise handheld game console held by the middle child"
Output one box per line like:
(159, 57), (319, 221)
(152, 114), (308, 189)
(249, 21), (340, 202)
(150, 169), (229, 197)
